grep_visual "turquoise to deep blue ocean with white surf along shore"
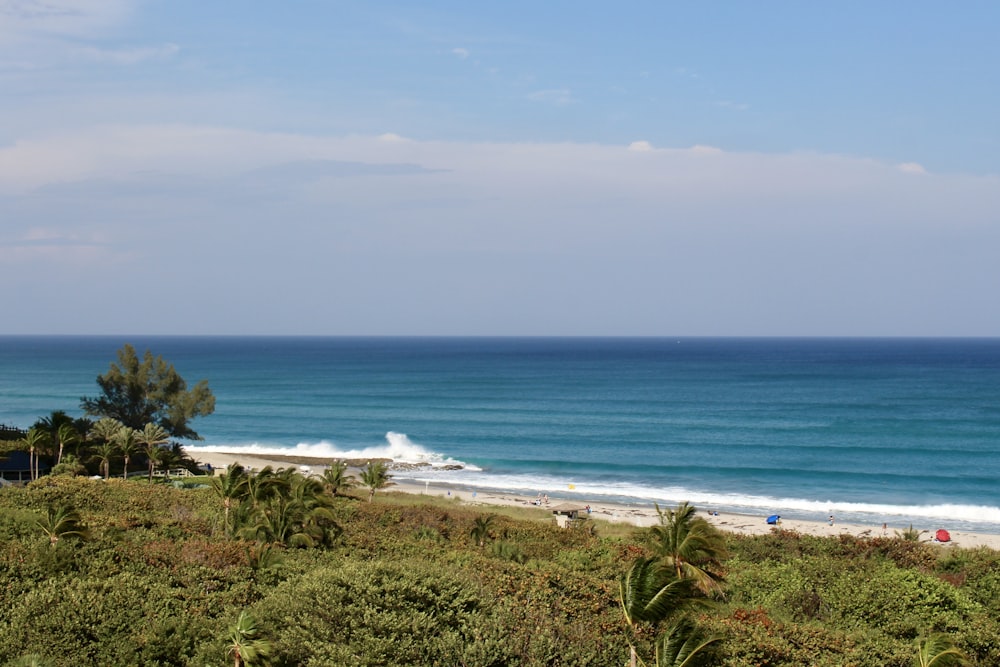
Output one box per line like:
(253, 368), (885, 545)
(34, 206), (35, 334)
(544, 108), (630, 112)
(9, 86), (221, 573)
(0, 336), (1000, 533)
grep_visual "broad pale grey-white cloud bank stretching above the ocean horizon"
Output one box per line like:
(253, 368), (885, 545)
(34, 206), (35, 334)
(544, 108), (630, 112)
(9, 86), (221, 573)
(0, 125), (1000, 334)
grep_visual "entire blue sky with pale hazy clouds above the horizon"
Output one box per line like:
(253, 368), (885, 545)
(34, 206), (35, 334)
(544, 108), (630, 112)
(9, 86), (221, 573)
(0, 0), (1000, 336)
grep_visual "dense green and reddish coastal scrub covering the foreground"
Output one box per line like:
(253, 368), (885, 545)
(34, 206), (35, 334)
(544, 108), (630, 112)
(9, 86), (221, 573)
(0, 478), (1000, 667)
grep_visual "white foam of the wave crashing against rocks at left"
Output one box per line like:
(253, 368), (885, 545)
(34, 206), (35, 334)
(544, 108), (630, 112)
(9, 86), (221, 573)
(184, 431), (479, 470)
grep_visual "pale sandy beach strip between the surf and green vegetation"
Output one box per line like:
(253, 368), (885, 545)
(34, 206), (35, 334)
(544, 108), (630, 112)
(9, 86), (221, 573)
(186, 452), (1000, 550)
